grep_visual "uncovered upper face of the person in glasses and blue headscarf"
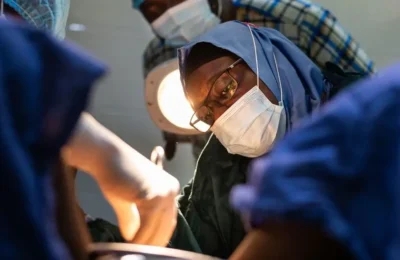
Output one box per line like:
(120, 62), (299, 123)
(185, 56), (278, 126)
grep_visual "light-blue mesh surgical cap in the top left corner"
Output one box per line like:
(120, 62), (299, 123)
(4, 0), (70, 39)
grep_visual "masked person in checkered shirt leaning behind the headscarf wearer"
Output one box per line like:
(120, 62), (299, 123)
(136, 0), (375, 159)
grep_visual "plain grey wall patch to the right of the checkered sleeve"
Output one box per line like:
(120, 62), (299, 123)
(315, 0), (400, 67)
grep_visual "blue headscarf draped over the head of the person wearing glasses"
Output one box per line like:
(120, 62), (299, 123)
(178, 21), (327, 129)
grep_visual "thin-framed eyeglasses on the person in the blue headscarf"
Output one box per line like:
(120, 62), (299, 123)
(189, 58), (243, 133)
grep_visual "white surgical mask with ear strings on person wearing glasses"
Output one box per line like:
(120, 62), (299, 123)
(211, 27), (286, 158)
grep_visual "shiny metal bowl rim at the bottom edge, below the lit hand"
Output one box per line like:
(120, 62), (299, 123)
(90, 243), (219, 260)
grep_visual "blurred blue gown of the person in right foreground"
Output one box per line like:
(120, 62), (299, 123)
(231, 63), (400, 260)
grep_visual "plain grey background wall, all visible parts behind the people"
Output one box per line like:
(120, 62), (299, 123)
(67, 0), (400, 222)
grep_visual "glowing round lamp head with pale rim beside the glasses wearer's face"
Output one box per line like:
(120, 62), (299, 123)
(144, 38), (204, 135)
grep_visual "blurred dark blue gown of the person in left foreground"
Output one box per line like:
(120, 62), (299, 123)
(0, 20), (105, 260)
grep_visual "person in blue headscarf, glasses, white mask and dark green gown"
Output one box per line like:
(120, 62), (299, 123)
(171, 21), (370, 258)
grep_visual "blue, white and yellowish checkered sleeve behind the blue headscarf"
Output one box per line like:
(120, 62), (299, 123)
(233, 0), (374, 73)
